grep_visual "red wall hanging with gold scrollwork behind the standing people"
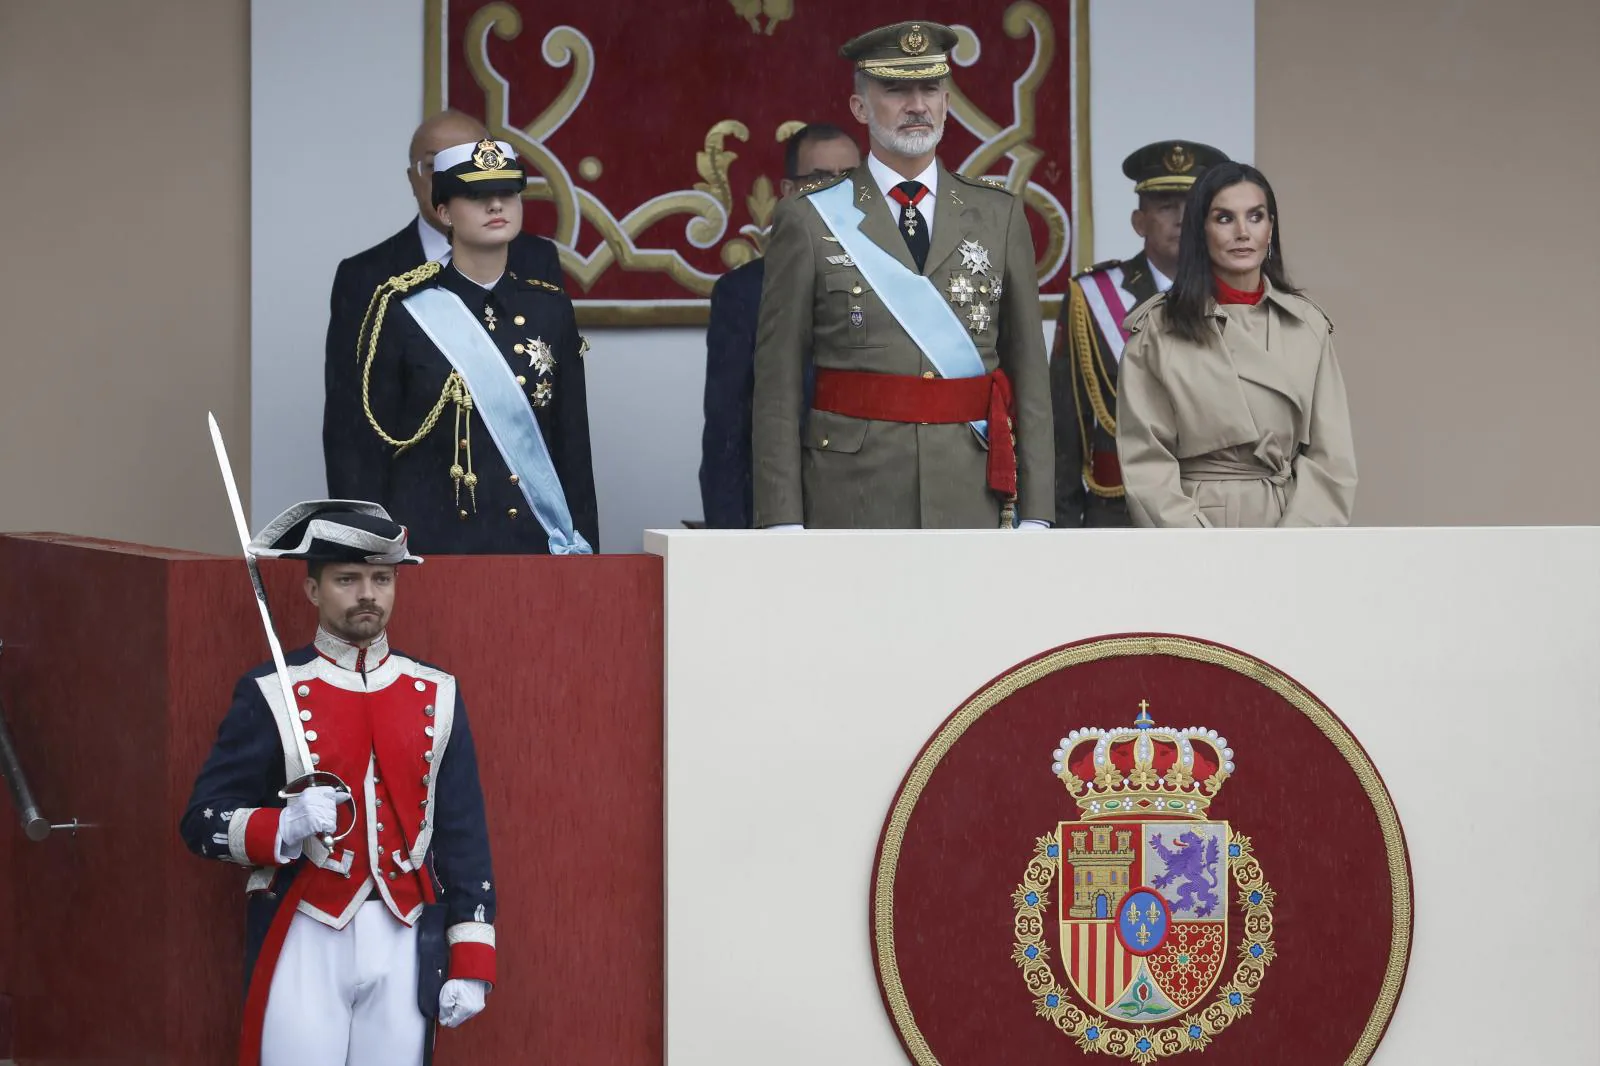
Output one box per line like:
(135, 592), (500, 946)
(426, 0), (1072, 312)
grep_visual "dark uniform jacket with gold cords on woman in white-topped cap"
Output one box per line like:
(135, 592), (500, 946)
(333, 266), (600, 555)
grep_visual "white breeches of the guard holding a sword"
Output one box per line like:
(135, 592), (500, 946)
(261, 900), (427, 1066)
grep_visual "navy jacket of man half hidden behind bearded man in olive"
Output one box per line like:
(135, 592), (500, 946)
(701, 259), (814, 530)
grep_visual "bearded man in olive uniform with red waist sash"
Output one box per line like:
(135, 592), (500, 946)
(752, 22), (1054, 528)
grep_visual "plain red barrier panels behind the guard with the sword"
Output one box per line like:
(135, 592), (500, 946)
(0, 536), (662, 1066)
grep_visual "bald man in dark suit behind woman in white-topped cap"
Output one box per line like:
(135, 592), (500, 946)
(322, 110), (562, 499)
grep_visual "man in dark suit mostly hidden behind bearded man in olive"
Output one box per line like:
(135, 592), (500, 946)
(701, 123), (861, 530)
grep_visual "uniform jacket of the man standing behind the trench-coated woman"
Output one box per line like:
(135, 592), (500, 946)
(1050, 251), (1157, 528)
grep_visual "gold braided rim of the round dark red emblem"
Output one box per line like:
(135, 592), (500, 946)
(872, 637), (1411, 1066)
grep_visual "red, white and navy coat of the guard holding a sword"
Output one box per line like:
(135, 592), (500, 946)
(181, 632), (496, 1061)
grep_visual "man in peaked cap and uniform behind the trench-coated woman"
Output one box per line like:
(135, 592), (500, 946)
(1050, 141), (1227, 528)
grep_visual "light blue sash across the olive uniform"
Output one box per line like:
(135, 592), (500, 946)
(806, 181), (989, 440)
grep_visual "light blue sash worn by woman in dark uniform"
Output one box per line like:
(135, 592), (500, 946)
(405, 288), (594, 555)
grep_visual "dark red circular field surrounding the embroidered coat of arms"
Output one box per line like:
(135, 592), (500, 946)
(874, 634), (1410, 1066)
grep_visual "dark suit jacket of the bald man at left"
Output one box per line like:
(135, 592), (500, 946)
(322, 219), (563, 502)
